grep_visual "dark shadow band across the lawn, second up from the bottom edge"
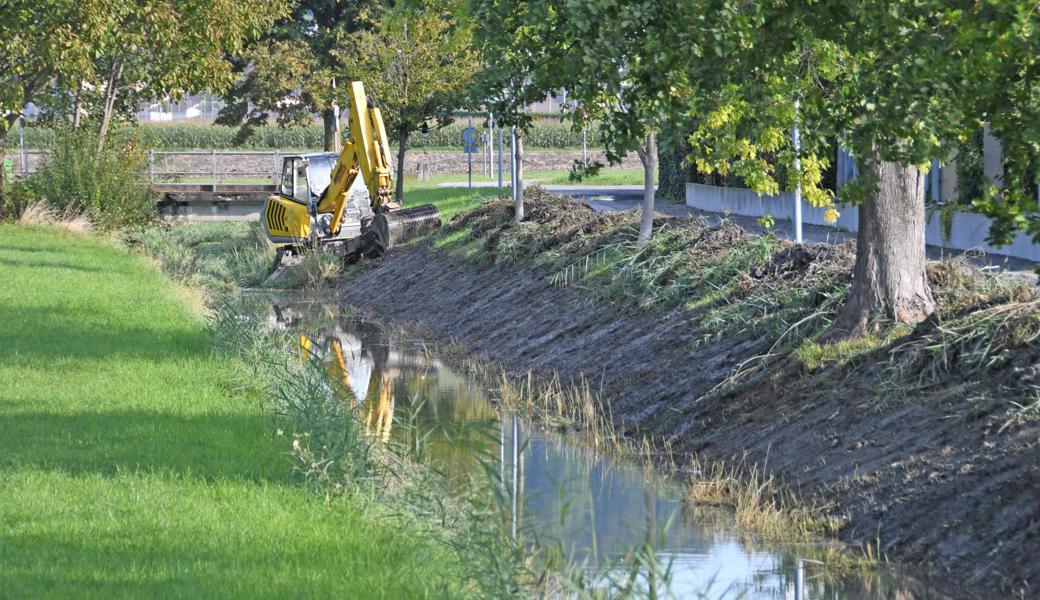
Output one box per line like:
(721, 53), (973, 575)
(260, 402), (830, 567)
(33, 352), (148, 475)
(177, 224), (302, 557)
(0, 411), (289, 482)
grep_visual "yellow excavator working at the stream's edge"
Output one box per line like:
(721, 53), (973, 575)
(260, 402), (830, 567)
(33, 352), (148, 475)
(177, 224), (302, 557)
(261, 81), (441, 270)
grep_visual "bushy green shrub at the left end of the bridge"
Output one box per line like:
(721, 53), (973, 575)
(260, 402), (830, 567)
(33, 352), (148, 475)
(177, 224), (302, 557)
(11, 130), (155, 229)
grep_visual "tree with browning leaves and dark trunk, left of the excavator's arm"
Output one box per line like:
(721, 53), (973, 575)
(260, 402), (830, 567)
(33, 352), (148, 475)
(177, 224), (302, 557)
(216, 0), (384, 151)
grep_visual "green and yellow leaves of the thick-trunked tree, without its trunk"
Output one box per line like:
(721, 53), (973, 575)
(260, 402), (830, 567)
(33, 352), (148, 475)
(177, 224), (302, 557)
(662, 0), (1040, 231)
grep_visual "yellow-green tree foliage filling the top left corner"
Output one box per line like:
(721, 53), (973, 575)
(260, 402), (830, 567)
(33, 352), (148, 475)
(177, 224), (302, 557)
(0, 0), (288, 145)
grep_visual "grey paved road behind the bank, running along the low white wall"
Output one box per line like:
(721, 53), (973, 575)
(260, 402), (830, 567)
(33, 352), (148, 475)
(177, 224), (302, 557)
(440, 182), (1038, 283)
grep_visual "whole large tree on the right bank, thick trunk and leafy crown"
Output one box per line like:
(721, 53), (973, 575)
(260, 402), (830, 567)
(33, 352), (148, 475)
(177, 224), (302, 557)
(653, 0), (1038, 335)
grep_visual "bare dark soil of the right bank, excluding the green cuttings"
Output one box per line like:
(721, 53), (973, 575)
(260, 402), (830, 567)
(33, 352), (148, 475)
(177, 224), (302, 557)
(341, 195), (1040, 597)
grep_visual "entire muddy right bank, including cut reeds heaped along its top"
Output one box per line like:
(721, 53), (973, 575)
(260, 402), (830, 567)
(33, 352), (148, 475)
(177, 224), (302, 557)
(341, 194), (1040, 597)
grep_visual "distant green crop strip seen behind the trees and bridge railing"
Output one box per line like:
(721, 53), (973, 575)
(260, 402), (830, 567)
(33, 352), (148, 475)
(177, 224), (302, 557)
(20, 122), (599, 150)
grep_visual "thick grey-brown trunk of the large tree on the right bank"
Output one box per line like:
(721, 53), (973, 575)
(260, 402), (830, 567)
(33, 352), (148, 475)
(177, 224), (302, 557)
(828, 160), (935, 339)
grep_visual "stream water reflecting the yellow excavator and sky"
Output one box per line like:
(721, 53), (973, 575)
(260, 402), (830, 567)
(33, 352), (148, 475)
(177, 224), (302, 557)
(242, 294), (942, 599)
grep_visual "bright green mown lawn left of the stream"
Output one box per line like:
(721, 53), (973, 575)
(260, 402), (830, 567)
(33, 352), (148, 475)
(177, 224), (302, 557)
(0, 225), (461, 598)
